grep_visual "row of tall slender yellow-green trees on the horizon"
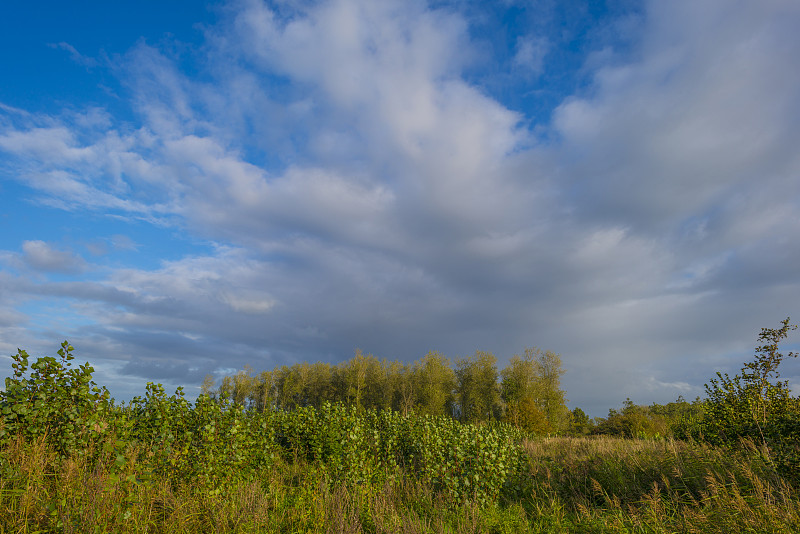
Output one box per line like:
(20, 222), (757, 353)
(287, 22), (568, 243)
(202, 348), (572, 433)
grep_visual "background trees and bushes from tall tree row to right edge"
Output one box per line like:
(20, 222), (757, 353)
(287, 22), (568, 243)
(203, 317), (800, 460)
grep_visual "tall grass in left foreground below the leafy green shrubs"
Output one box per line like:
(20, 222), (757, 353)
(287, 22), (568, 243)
(0, 432), (525, 533)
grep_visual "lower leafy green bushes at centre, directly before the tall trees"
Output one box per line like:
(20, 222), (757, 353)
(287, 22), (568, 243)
(273, 404), (521, 502)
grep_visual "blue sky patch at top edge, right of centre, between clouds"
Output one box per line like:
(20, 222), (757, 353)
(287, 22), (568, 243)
(456, 0), (642, 129)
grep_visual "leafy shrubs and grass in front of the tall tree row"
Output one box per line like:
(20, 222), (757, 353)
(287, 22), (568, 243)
(0, 343), (800, 534)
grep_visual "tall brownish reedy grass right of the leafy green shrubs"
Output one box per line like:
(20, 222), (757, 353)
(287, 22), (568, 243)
(523, 437), (800, 533)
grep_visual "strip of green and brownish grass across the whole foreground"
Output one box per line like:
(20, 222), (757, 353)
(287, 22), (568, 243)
(0, 437), (800, 534)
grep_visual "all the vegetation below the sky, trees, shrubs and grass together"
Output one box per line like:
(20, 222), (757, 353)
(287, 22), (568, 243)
(0, 319), (800, 533)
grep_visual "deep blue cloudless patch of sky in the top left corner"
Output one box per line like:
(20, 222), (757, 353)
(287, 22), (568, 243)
(0, 0), (216, 113)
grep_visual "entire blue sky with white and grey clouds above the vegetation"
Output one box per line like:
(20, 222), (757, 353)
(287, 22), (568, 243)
(0, 0), (800, 416)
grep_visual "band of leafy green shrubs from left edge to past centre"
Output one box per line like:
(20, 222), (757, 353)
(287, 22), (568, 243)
(0, 343), (522, 508)
